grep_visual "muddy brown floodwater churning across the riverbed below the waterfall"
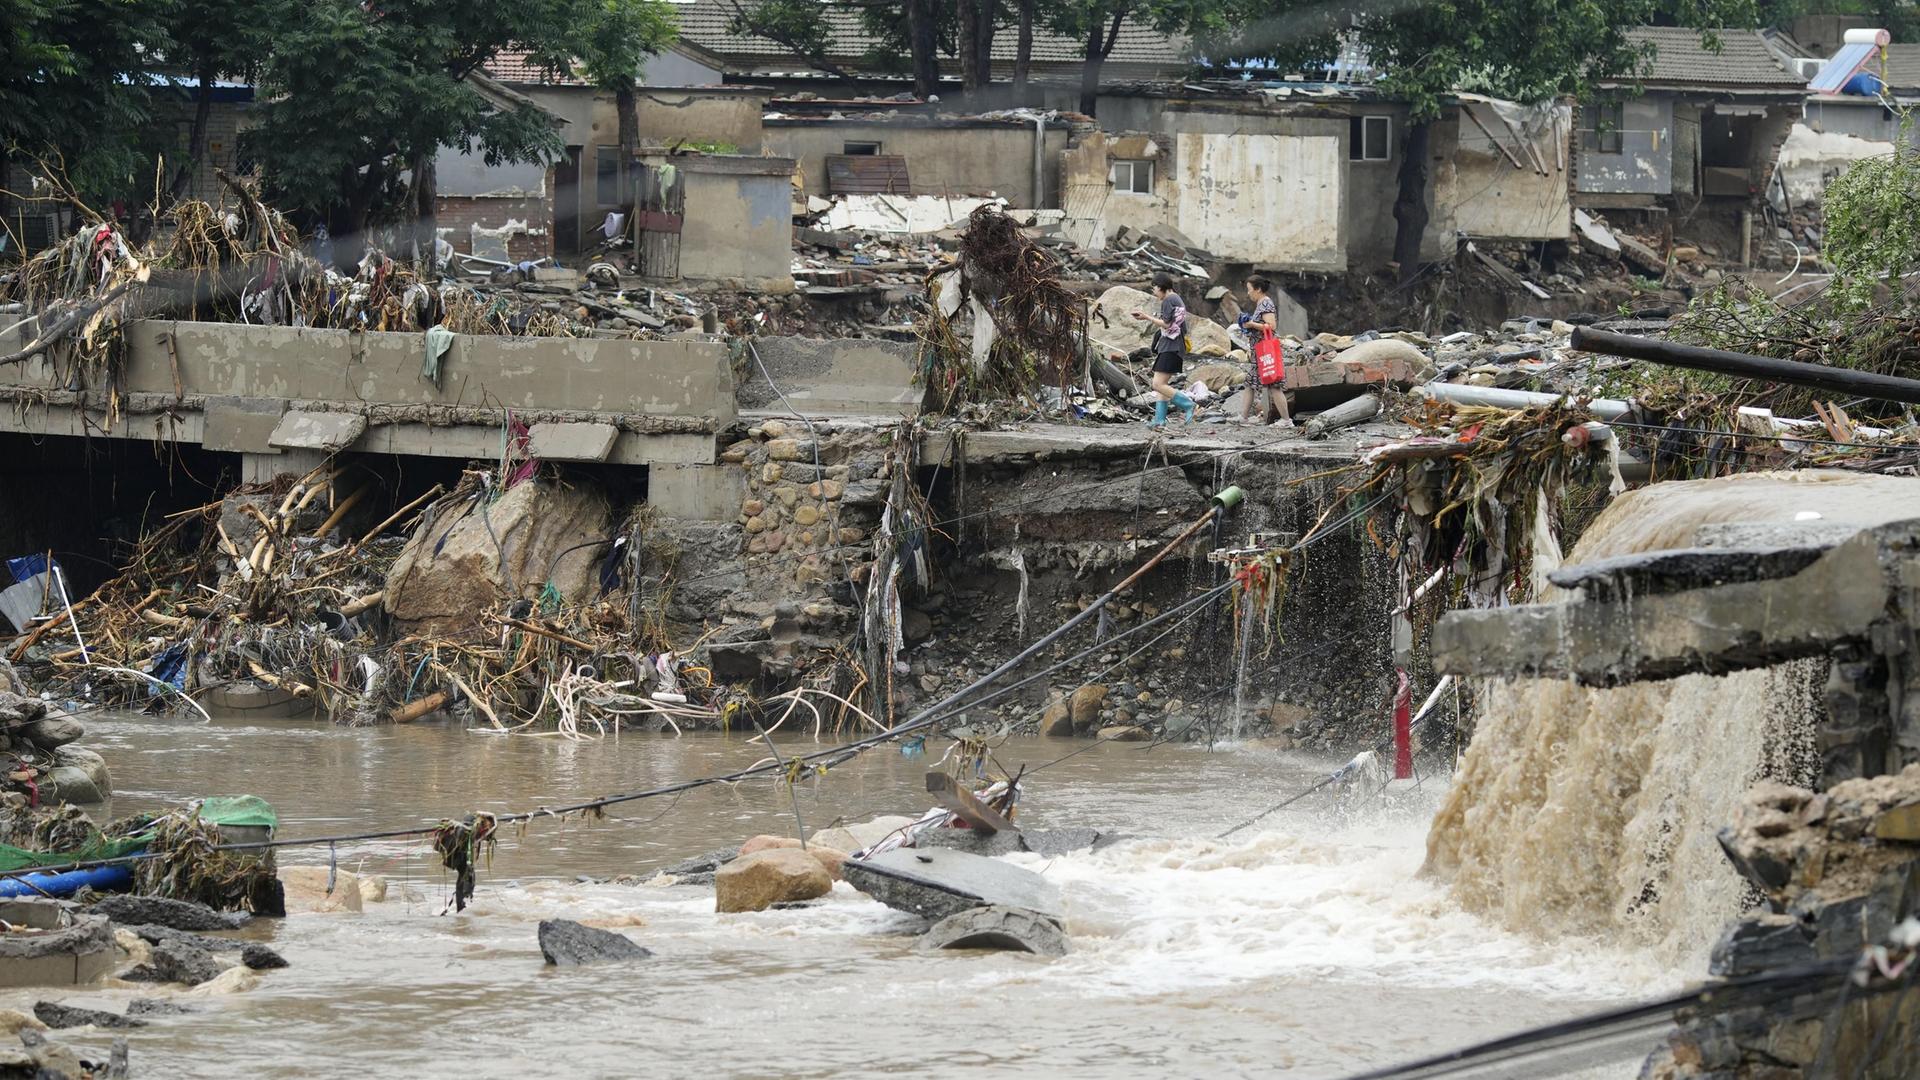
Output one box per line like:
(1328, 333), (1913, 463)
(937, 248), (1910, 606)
(0, 715), (1682, 1080)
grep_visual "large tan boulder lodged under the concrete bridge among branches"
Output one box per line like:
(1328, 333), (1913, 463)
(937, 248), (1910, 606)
(386, 480), (609, 636)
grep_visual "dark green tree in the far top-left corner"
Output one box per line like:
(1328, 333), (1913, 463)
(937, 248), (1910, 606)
(0, 0), (167, 198)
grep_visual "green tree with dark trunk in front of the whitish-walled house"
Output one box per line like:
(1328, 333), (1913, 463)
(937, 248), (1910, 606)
(1236, 0), (1759, 281)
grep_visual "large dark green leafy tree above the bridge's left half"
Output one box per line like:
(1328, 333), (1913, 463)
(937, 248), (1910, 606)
(248, 0), (599, 253)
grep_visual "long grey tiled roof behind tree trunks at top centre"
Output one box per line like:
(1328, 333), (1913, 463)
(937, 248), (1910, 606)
(674, 0), (1187, 75)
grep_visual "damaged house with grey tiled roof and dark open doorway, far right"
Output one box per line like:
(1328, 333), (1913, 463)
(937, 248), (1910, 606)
(1572, 27), (1807, 256)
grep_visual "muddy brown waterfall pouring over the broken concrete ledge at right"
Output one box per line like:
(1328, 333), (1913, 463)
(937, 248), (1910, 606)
(1427, 471), (1920, 960)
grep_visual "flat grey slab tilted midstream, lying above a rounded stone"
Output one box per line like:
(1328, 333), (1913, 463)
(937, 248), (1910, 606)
(843, 847), (1060, 919)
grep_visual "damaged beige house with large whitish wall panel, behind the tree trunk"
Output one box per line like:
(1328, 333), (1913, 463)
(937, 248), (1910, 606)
(1062, 81), (1571, 273)
